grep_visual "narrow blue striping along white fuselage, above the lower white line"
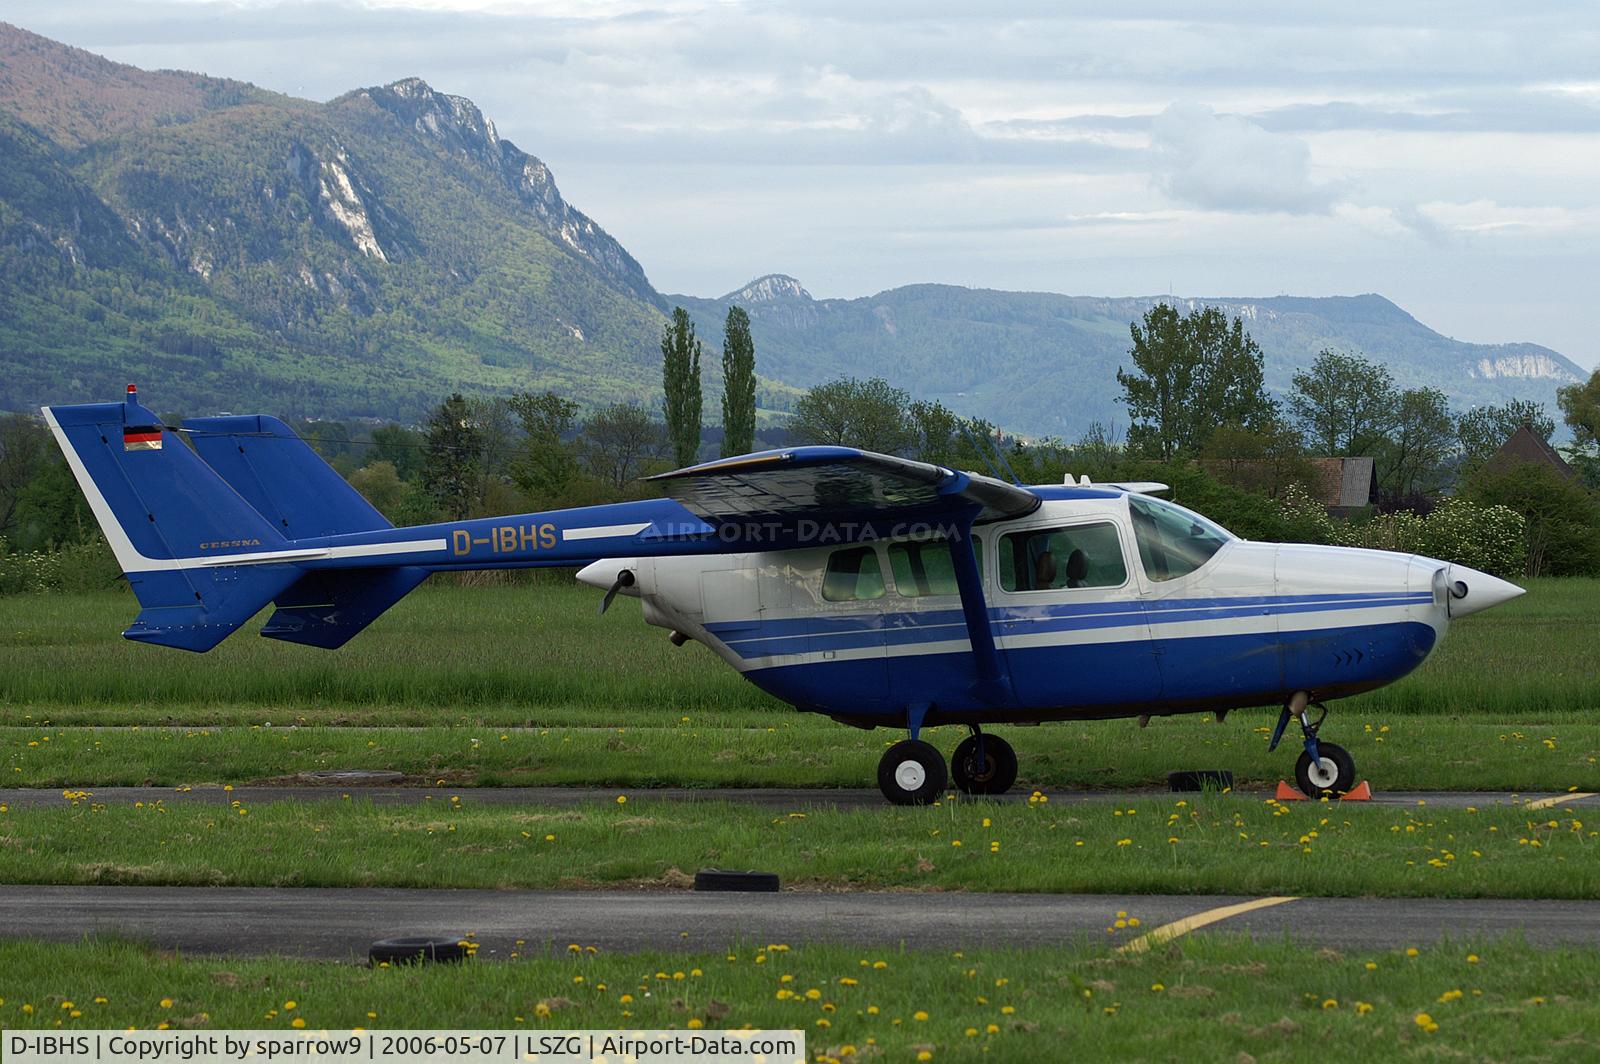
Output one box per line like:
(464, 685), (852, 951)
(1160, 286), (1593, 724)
(706, 592), (1434, 659)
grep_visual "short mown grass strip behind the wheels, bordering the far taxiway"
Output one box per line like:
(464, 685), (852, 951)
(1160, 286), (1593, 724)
(0, 712), (1600, 790)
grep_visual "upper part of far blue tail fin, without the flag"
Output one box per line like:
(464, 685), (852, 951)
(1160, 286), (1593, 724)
(184, 414), (394, 539)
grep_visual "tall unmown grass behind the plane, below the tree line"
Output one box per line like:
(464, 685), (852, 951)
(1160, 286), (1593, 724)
(0, 573), (1600, 726)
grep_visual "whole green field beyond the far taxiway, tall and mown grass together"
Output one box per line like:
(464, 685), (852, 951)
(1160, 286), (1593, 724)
(0, 576), (1600, 790)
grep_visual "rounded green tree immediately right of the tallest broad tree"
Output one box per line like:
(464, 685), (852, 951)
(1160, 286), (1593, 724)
(1290, 349), (1398, 458)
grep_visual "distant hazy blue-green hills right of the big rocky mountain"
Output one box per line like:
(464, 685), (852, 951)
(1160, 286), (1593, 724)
(667, 274), (1589, 438)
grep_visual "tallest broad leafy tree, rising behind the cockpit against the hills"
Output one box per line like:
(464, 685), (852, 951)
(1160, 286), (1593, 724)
(1117, 302), (1277, 461)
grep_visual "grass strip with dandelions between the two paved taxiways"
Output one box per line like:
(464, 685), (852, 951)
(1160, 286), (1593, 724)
(0, 792), (1600, 898)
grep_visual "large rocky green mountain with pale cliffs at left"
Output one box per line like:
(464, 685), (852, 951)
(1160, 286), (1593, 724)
(0, 24), (664, 418)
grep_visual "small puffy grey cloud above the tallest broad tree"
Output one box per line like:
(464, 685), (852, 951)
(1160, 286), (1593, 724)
(1150, 104), (1341, 214)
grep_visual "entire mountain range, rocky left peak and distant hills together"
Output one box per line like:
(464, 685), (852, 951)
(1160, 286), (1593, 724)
(0, 22), (1584, 437)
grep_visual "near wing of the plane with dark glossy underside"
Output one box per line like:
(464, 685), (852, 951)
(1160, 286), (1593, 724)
(651, 446), (1040, 538)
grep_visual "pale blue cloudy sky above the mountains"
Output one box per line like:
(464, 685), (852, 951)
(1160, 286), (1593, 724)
(0, 0), (1600, 368)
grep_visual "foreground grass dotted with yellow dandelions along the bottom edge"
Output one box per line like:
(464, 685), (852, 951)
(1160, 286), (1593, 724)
(0, 936), (1600, 1064)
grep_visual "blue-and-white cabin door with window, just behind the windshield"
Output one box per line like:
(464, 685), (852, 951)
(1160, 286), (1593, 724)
(990, 515), (1162, 709)
